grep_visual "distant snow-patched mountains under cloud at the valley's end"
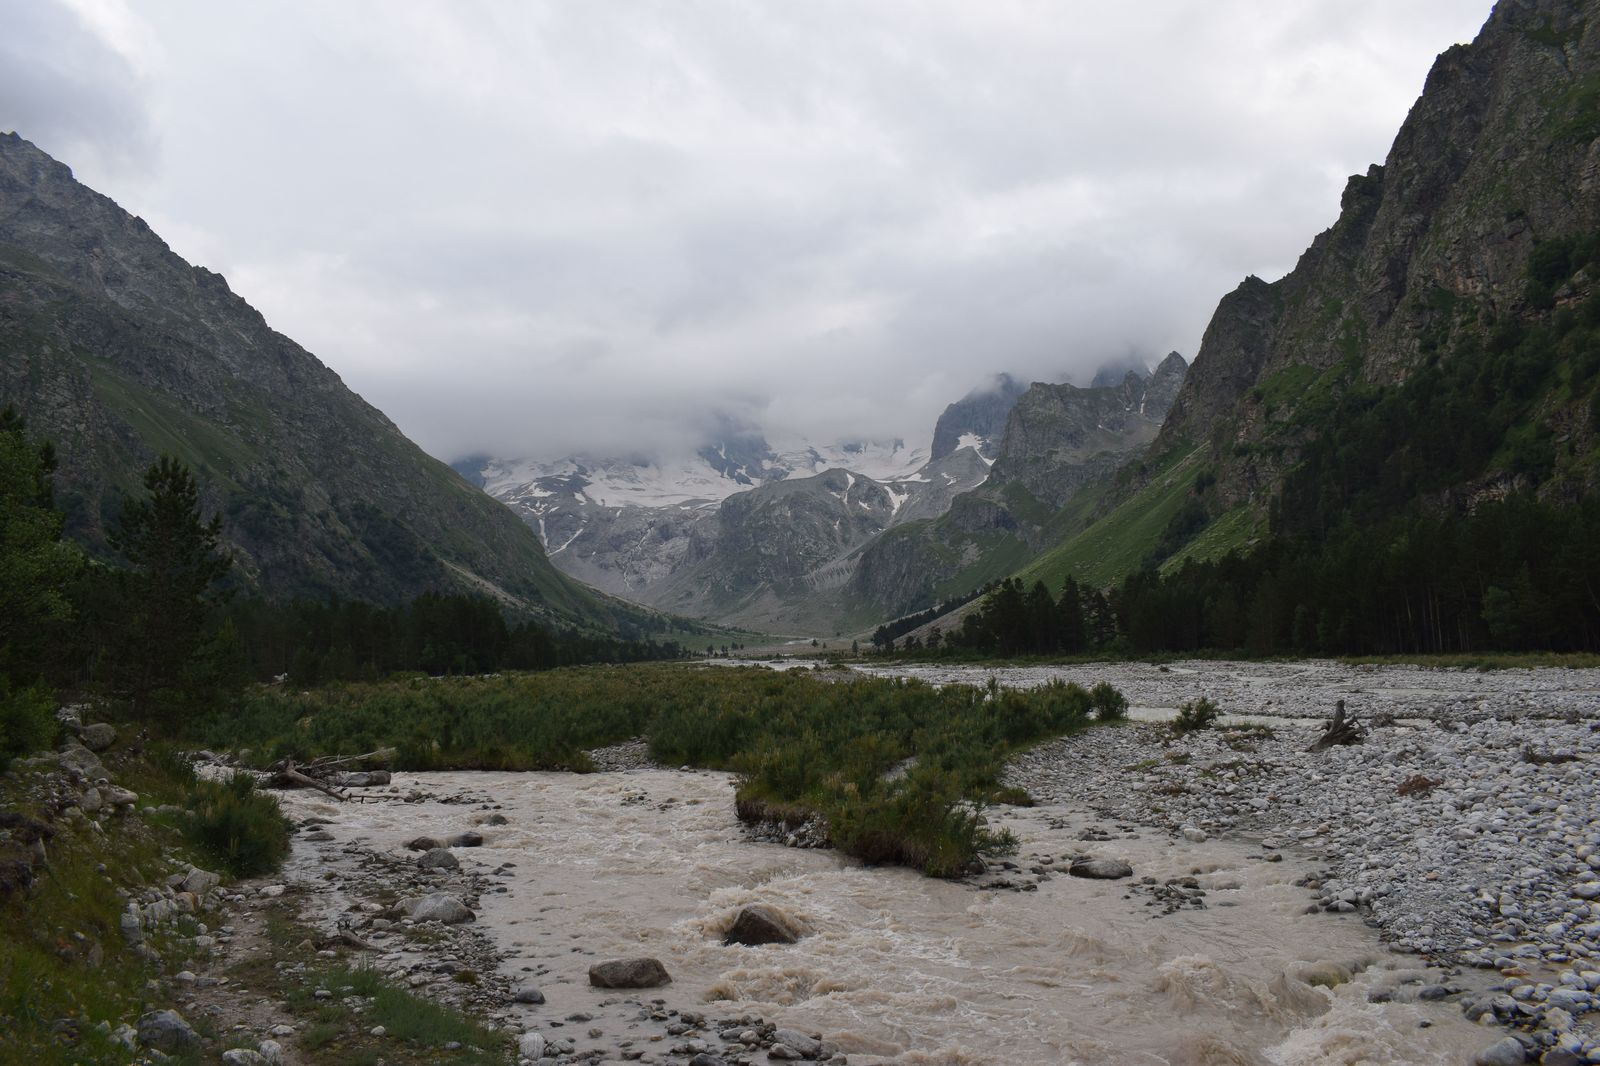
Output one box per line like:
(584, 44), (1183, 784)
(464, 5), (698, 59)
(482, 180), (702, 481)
(458, 355), (1184, 632)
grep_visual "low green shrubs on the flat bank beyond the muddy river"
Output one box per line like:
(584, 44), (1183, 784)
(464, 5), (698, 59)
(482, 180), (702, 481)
(202, 666), (1126, 876)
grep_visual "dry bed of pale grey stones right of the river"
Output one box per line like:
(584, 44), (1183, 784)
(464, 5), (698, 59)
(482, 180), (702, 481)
(874, 663), (1600, 1063)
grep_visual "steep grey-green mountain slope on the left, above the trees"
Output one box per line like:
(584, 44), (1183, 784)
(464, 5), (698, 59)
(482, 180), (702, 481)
(0, 133), (616, 621)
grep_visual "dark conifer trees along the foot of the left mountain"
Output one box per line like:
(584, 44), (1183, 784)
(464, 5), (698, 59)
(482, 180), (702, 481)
(0, 408), (685, 745)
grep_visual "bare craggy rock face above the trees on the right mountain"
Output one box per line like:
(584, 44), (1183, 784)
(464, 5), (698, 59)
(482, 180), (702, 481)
(1155, 0), (1600, 503)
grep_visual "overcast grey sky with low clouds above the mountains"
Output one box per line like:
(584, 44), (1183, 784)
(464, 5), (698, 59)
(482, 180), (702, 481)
(0, 0), (1490, 459)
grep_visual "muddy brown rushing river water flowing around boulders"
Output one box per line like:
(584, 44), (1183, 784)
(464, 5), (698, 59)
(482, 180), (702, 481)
(278, 770), (1490, 1066)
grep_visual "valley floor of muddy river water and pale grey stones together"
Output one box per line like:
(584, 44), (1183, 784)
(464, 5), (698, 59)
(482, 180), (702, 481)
(246, 663), (1600, 1064)
